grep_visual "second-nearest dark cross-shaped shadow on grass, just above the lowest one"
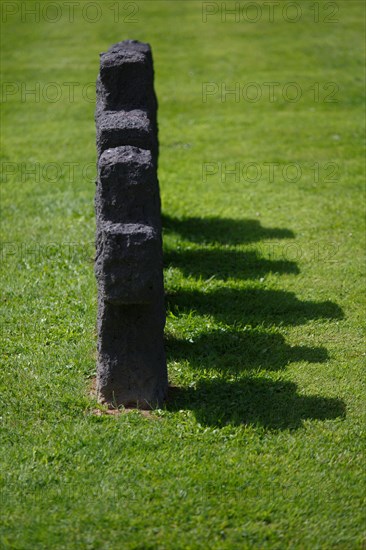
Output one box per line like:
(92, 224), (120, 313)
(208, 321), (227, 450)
(165, 330), (329, 376)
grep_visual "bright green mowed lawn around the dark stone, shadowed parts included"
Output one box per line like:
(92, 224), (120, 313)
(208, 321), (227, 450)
(0, 0), (365, 550)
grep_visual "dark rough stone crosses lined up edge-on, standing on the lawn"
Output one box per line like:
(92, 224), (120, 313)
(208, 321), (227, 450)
(95, 40), (168, 408)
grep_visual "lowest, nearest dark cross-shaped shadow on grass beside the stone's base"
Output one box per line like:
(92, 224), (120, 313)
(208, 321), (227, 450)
(168, 377), (345, 430)
